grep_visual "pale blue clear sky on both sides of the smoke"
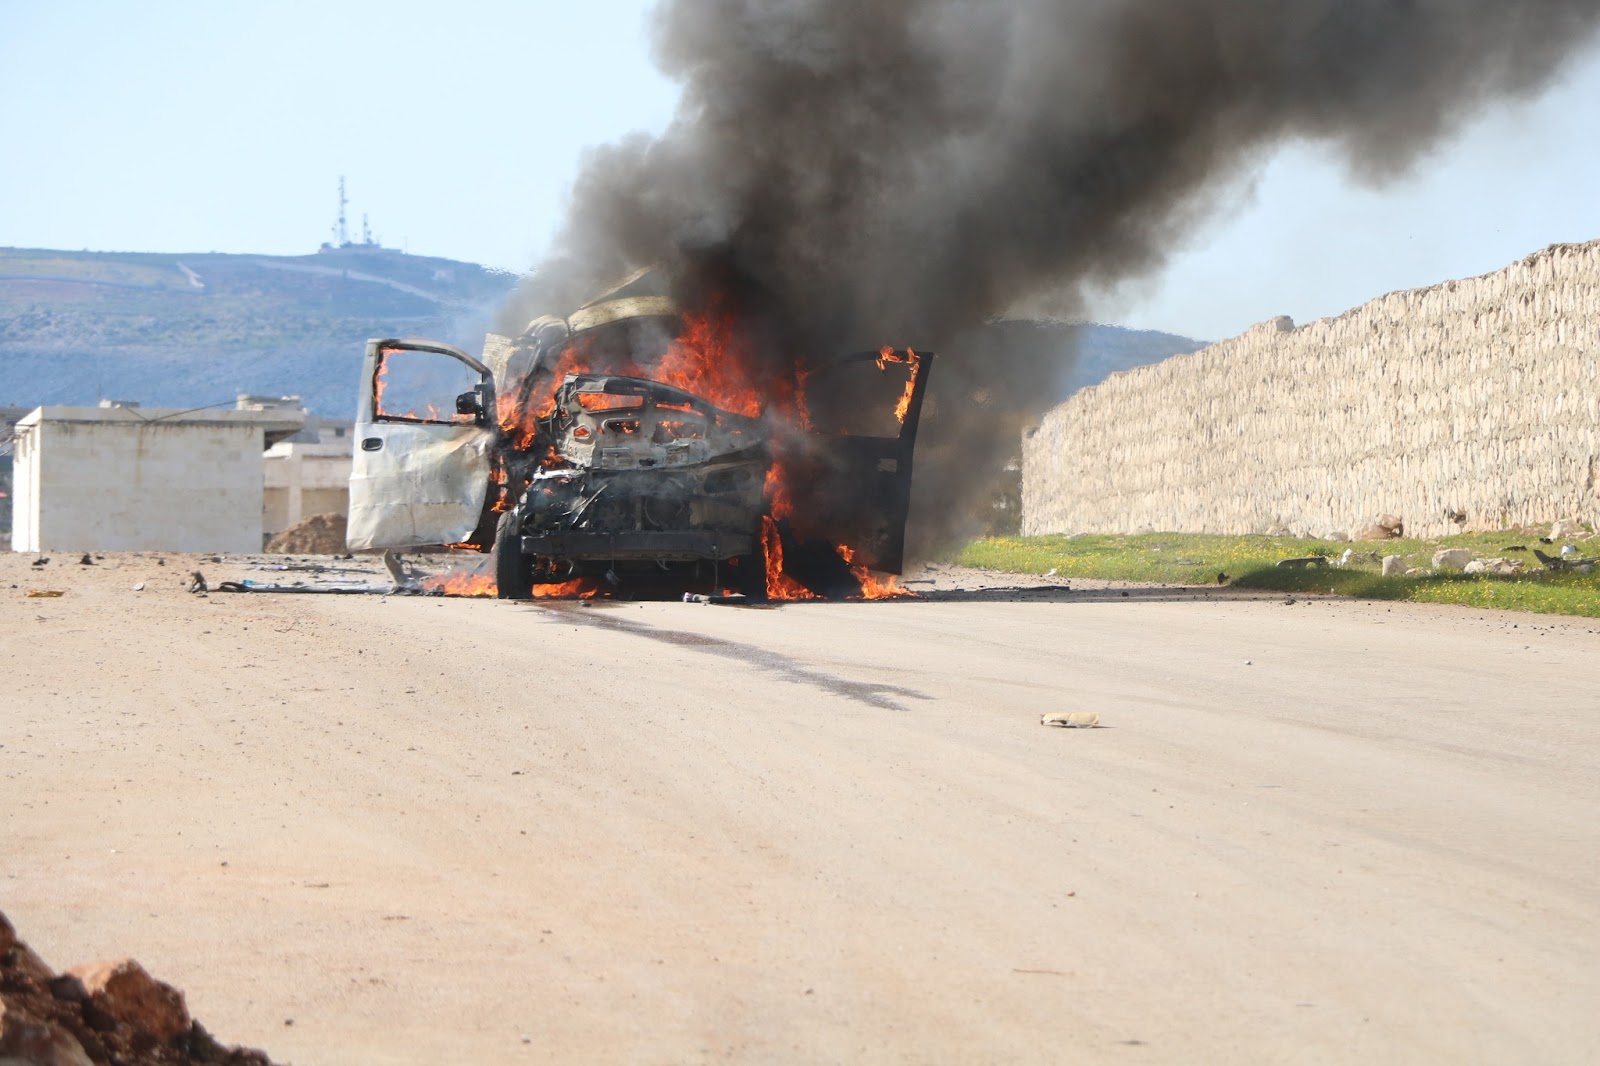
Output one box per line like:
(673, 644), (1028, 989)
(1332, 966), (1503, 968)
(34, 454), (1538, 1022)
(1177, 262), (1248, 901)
(0, 0), (1600, 338)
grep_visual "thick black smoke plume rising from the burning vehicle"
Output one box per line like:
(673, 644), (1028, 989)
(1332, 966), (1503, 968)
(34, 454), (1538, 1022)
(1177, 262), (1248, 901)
(509, 0), (1600, 550)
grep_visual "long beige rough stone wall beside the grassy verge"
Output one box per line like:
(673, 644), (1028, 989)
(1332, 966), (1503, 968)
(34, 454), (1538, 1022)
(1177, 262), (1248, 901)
(1022, 242), (1600, 536)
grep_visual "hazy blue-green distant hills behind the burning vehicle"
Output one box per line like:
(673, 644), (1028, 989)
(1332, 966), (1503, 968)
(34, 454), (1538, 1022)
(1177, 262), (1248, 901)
(0, 245), (1200, 418)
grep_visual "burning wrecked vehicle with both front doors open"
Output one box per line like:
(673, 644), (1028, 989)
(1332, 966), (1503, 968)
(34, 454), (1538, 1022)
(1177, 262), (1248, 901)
(349, 279), (931, 599)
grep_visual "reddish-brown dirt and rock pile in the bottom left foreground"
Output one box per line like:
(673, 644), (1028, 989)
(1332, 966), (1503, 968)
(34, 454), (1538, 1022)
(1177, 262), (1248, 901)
(0, 914), (272, 1066)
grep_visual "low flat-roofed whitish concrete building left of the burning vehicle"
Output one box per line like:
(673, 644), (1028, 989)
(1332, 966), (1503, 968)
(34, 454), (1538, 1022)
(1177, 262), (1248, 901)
(11, 398), (306, 552)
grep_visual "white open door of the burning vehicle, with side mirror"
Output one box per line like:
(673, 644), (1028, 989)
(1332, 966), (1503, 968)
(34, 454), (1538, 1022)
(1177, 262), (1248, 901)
(346, 339), (498, 549)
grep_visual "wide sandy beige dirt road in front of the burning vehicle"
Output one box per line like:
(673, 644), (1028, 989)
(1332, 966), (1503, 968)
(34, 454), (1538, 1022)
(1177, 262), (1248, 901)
(0, 555), (1600, 1066)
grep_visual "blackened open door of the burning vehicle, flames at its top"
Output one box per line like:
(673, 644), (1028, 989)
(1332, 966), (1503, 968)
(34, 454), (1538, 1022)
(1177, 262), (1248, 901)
(795, 349), (933, 573)
